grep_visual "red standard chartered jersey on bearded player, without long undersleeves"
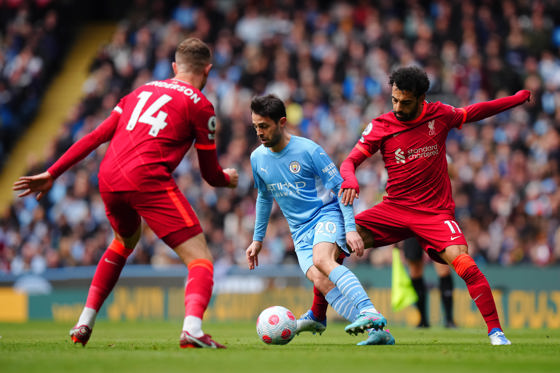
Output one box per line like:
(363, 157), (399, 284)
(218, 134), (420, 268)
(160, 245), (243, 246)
(356, 102), (467, 214)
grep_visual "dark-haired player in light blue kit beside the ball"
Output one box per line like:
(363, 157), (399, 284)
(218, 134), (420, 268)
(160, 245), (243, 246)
(246, 95), (395, 345)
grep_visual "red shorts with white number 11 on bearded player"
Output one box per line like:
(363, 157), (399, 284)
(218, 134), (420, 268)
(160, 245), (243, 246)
(356, 201), (467, 264)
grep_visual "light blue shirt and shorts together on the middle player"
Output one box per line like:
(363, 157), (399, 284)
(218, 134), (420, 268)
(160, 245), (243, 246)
(251, 136), (356, 273)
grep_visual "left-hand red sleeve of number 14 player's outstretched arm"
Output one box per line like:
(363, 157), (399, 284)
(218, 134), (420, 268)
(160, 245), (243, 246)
(47, 110), (121, 179)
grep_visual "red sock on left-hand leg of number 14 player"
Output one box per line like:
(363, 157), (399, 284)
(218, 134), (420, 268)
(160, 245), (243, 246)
(86, 240), (132, 312)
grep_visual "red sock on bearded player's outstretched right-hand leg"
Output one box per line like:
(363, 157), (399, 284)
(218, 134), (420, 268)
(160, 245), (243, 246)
(453, 254), (502, 333)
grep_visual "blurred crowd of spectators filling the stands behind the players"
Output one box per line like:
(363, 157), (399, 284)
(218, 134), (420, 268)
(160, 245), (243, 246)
(0, 0), (560, 274)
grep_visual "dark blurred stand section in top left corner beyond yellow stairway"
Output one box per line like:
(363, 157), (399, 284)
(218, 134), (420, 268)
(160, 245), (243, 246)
(0, 0), (73, 169)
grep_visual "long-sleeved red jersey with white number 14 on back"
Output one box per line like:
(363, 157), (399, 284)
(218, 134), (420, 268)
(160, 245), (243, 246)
(48, 79), (222, 192)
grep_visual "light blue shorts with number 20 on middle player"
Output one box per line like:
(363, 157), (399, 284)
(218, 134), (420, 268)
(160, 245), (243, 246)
(294, 210), (350, 274)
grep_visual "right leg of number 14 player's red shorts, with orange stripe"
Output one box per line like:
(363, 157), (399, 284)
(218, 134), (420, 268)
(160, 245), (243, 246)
(134, 186), (202, 248)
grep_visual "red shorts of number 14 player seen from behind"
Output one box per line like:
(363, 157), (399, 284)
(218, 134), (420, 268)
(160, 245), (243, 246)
(101, 185), (202, 248)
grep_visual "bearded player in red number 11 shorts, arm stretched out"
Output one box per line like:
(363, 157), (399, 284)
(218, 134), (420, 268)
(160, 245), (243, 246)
(340, 67), (531, 345)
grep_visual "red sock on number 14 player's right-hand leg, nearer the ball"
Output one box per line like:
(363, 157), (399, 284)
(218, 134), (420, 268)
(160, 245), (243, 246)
(185, 259), (214, 319)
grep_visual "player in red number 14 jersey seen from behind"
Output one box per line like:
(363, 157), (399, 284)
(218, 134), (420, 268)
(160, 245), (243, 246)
(14, 38), (238, 348)
